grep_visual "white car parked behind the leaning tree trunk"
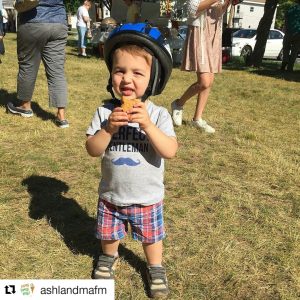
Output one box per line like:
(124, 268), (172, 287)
(232, 29), (284, 60)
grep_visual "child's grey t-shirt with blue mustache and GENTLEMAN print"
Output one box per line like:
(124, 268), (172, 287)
(87, 100), (175, 206)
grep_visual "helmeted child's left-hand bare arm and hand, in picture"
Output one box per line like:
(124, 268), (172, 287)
(85, 107), (128, 157)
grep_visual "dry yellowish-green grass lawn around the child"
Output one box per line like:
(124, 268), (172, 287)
(0, 34), (300, 300)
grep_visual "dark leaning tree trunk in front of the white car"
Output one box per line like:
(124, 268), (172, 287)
(246, 0), (278, 67)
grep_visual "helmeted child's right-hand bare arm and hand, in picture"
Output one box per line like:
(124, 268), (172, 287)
(128, 102), (178, 158)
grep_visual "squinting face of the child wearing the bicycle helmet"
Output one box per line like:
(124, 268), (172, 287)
(111, 50), (151, 99)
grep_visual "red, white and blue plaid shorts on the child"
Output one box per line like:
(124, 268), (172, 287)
(96, 199), (165, 244)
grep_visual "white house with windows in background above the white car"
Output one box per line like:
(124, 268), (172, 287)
(232, 0), (277, 29)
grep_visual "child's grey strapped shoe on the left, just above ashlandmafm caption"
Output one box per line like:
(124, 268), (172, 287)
(94, 254), (118, 279)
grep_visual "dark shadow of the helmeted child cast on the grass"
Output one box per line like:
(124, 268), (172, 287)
(22, 175), (146, 288)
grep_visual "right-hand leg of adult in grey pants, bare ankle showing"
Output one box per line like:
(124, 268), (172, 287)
(42, 24), (68, 121)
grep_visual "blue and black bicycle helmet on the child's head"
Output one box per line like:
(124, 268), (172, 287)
(104, 23), (173, 101)
